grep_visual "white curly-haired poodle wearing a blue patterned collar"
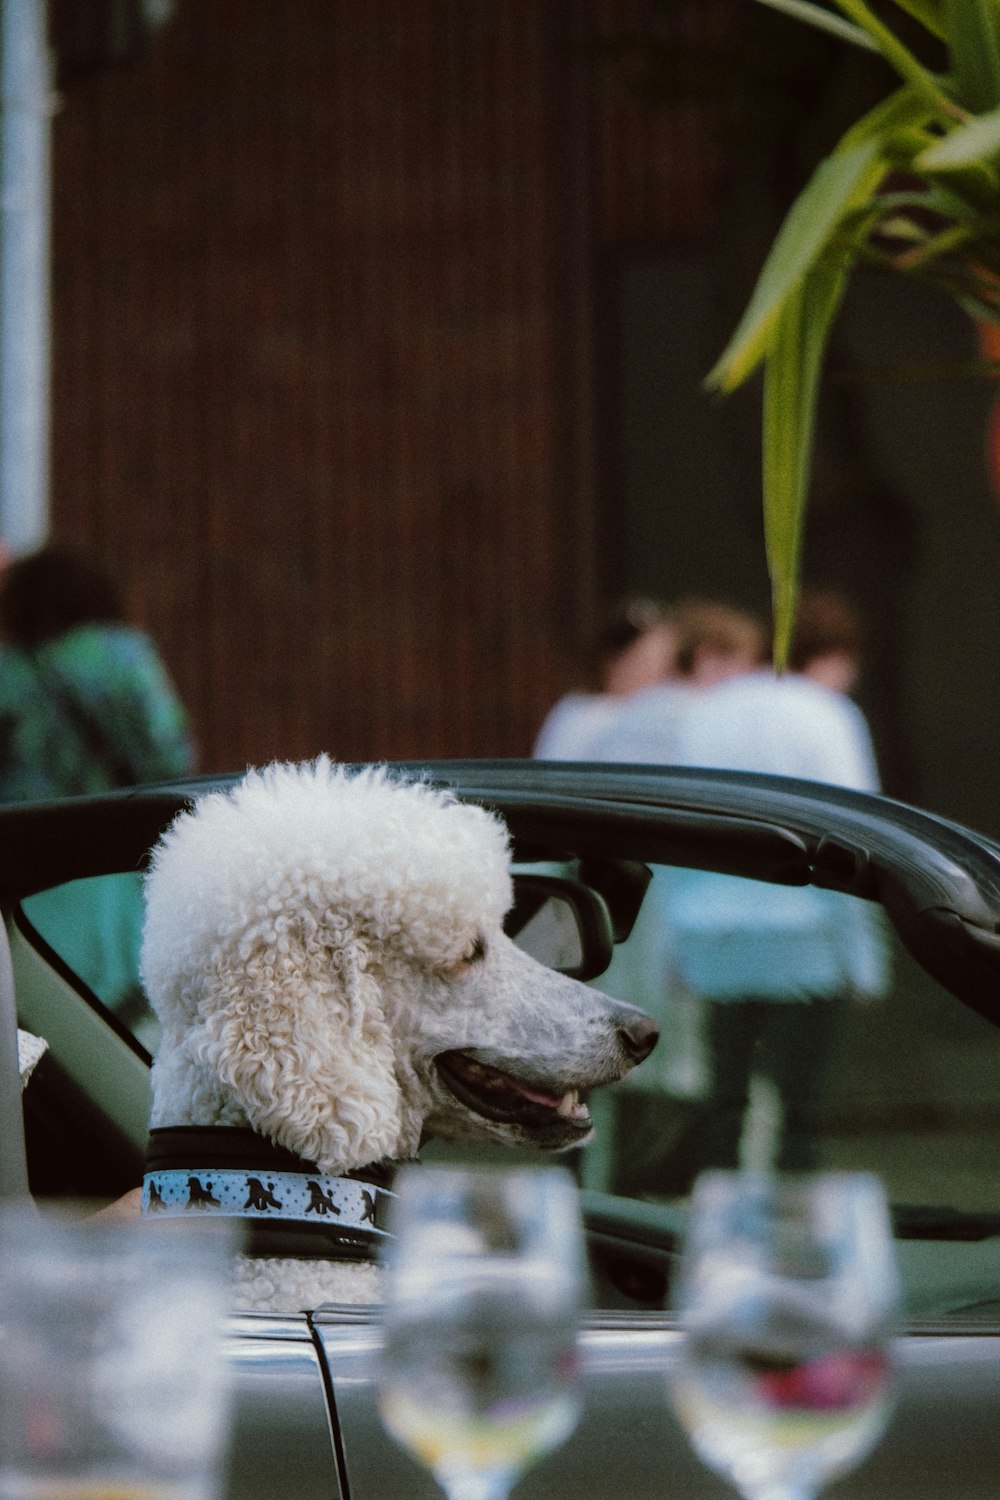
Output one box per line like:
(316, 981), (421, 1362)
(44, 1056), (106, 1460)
(142, 758), (657, 1308)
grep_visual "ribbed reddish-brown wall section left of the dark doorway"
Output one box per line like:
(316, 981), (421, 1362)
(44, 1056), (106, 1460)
(52, 0), (620, 770)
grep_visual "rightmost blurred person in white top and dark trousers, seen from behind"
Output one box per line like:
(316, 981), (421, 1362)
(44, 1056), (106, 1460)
(667, 590), (888, 1176)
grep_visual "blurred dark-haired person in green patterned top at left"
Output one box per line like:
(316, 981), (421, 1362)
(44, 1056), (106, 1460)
(0, 542), (195, 1010)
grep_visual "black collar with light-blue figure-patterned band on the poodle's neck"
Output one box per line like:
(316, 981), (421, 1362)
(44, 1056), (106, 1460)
(142, 1125), (393, 1260)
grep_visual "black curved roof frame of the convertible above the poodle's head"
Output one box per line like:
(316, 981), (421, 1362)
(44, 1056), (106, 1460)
(0, 761), (1000, 1023)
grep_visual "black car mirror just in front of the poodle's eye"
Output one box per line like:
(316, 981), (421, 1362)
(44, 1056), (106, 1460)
(504, 873), (615, 980)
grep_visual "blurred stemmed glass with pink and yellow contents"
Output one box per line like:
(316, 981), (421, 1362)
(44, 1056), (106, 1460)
(670, 1172), (898, 1500)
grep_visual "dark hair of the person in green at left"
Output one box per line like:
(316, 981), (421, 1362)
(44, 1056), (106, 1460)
(0, 542), (126, 650)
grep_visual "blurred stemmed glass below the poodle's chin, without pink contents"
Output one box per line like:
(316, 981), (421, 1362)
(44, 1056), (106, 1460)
(379, 1166), (585, 1500)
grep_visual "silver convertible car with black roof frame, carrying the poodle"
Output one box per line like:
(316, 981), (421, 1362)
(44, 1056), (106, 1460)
(0, 762), (1000, 1500)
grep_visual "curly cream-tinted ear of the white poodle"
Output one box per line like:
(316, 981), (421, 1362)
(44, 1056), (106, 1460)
(196, 918), (402, 1172)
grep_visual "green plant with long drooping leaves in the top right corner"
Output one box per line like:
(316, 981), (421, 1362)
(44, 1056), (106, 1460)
(731, 0), (1000, 668)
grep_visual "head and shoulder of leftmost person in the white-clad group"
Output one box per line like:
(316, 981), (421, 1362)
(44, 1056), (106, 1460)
(532, 597), (676, 761)
